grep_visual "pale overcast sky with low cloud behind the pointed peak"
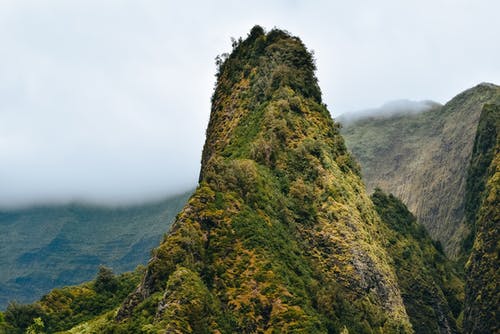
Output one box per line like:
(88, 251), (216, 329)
(0, 0), (500, 206)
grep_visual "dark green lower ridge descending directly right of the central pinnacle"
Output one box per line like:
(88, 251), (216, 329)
(371, 189), (464, 334)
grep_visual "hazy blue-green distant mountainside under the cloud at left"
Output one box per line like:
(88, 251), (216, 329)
(0, 192), (191, 309)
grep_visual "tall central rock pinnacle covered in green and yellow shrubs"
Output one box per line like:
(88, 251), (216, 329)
(117, 27), (412, 333)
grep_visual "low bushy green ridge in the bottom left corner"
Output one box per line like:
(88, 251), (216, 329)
(0, 266), (143, 334)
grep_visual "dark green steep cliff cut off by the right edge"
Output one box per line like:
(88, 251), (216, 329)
(464, 104), (500, 333)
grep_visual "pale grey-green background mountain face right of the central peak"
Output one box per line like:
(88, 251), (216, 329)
(342, 84), (500, 258)
